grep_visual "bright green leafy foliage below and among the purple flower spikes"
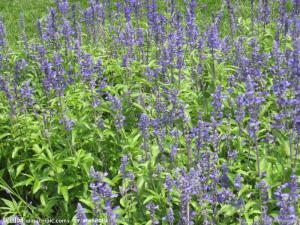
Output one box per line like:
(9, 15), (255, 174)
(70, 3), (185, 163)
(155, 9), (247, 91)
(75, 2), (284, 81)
(0, 0), (300, 225)
